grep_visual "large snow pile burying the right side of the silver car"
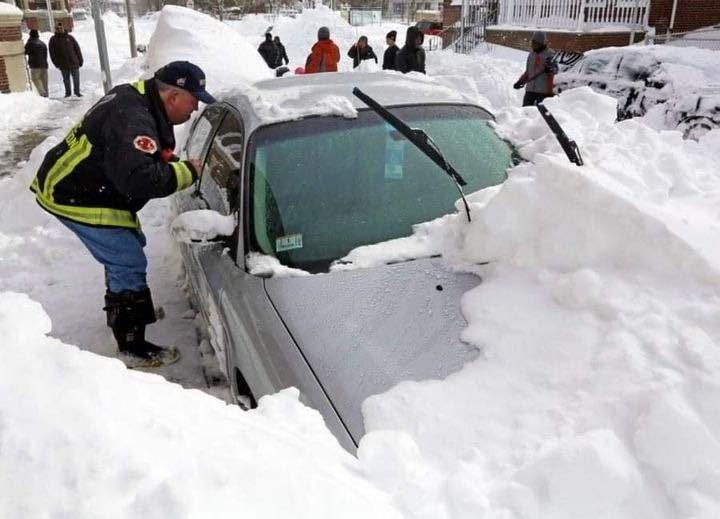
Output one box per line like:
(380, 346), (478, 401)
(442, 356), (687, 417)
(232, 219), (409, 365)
(358, 88), (720, 519)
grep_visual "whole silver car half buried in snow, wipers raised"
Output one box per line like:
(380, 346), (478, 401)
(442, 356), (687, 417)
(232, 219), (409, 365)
(177, 73), (514, 450)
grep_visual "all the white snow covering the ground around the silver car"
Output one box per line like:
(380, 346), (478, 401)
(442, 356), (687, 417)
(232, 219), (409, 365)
(0, 4), (720, 519)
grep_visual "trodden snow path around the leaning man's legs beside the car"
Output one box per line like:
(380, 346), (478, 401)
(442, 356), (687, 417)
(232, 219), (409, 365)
(0, 92), (229, 400)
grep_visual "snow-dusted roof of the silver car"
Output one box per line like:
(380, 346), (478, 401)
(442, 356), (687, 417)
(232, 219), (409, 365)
(218, 72), (486, 134)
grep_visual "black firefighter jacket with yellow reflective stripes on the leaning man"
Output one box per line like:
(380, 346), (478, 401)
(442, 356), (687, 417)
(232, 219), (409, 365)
(31, 79), (198, 227)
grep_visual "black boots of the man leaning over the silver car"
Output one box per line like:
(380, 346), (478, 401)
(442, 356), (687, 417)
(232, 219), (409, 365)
(105, 289), (180, 367)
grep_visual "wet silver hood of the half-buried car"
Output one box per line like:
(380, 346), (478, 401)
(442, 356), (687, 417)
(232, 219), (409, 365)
(265, 258), (481, 442)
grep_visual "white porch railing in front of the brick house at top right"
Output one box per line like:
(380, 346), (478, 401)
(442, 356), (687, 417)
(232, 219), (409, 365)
(498, 0), (650, 31)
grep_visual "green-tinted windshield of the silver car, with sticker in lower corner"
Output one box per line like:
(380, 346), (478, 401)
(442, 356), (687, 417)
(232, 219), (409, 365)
(249, 105), (512, 272)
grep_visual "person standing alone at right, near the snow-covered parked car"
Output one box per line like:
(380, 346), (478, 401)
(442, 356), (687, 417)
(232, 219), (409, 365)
(513, 31), (558, 106)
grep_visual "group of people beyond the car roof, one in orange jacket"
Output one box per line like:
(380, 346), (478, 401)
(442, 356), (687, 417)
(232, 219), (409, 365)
(258, 26), (425, 75)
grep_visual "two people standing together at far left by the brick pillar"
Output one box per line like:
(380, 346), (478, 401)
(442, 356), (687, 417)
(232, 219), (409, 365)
(25, 22), (83, 97)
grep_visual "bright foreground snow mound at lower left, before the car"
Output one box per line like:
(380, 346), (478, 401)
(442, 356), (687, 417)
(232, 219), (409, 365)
(0, 292), (400, 519)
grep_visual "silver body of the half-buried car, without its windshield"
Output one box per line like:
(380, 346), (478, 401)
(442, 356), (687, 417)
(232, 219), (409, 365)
(178, 73), (500, 451)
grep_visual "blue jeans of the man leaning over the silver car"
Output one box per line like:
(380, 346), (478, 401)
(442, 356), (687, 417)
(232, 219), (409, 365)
(58, 218), (147, 293)
